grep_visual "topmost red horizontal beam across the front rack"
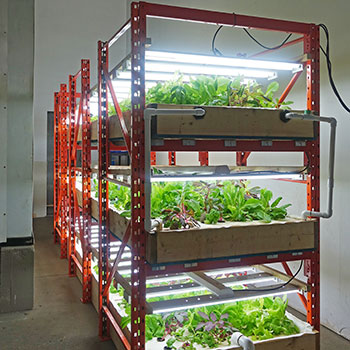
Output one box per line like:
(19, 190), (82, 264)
(140, 2), (314, 34)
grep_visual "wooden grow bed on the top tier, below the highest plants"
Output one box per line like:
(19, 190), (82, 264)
(78, 104), (315, 141)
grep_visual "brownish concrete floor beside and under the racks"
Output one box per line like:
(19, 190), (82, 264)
(0, 218), (350, 350)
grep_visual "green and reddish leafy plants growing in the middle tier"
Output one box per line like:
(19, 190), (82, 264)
(103, 181), (290, 229)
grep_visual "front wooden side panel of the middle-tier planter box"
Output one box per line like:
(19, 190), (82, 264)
(157, 221), (315, 263)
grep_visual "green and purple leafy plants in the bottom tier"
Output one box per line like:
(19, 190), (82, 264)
(122, 297), (299, 349)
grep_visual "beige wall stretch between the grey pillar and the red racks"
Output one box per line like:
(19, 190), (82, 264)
(34, 0), (126, 216)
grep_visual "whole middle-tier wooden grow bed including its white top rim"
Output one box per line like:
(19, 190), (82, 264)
(77, 189), (317, 264)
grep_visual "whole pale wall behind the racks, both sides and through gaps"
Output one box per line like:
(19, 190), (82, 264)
(34, 0), (350, 339)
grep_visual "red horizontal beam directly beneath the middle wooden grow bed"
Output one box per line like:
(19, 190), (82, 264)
(146, 251), (314, 276)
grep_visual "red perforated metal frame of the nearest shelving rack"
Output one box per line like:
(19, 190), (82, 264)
(98, 2), (320, 350)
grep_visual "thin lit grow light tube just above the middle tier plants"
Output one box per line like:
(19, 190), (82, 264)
(151, 173), (303, 182)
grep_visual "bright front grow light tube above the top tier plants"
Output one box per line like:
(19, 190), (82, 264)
(146, 50), (303, 72)
